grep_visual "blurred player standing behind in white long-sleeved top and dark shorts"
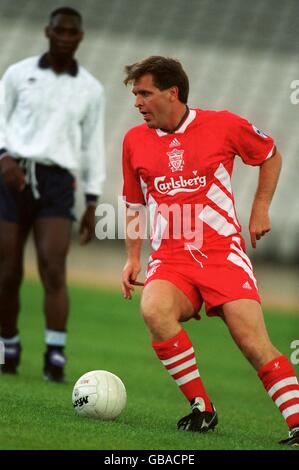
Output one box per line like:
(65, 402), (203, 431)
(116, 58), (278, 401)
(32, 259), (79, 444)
(0, 8), (104, 382)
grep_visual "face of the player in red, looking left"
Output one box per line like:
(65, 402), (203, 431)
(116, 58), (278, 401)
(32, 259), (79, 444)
(132, 74), (172, 129)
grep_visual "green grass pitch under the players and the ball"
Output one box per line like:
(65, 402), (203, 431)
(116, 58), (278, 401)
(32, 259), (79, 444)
(0, 282), (299, 450)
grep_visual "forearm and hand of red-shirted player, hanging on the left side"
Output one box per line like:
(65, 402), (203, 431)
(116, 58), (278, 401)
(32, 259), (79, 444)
(121, 209), (143, 299)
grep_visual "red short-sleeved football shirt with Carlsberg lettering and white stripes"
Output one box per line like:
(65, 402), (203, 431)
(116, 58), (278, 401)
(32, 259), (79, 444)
(123, 109), (275, 256)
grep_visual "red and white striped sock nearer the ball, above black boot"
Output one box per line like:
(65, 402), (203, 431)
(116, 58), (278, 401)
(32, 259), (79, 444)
(152, 329), (213, 411)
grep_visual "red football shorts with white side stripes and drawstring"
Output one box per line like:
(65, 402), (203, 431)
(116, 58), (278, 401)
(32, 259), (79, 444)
(145, 236), (261, 318)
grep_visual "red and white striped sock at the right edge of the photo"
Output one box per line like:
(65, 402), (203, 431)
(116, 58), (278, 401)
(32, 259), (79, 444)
(258, 356), (299, 429)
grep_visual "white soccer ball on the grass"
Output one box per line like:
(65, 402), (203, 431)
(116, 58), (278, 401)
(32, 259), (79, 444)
(72, 370), (127, 421)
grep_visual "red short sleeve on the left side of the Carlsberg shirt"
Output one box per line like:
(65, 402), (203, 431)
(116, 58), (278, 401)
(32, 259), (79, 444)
(122, 136), (145, 209)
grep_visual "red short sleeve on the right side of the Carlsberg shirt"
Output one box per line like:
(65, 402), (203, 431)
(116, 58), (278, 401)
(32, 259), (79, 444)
(229, 114), (275, 166)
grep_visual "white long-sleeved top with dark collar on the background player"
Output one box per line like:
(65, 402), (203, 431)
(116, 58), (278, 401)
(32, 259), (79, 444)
(0, 56), (105, 195)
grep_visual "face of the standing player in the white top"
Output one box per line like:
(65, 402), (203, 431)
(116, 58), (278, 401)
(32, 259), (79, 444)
(46, 14), (83, 58)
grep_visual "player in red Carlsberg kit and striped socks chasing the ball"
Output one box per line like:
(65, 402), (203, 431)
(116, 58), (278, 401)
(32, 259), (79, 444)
(122, 56), (299, 445)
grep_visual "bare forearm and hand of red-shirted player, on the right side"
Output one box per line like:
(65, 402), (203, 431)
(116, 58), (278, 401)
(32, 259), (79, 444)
(249, 151), (282, 248)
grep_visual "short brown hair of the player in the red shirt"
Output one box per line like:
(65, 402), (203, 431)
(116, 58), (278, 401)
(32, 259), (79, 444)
(124, 55), (189, 104)
